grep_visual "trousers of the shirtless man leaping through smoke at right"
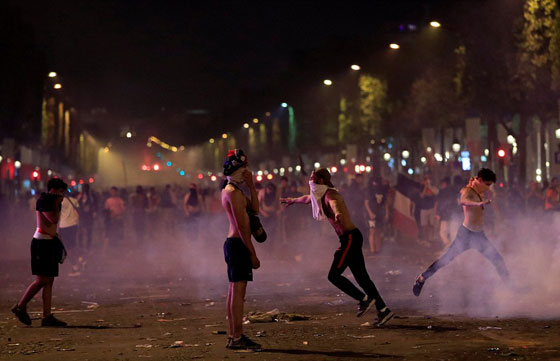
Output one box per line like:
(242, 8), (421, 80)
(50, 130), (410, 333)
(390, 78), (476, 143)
(422, 225), (509, 281)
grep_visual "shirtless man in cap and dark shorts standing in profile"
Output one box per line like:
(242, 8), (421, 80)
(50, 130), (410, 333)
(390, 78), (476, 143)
(222, 149), (262, 350)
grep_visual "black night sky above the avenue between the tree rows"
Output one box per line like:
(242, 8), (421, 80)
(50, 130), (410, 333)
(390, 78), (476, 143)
(15, 0), (445, 143)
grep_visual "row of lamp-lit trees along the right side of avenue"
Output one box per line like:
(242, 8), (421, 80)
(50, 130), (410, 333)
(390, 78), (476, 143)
(286, 0), (560, 184)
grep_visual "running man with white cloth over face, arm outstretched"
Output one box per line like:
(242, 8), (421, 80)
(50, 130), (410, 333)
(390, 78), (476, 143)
(280, 168), (394, 326)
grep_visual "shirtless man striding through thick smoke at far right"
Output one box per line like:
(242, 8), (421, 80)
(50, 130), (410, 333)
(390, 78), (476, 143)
(412, 168), (509, 296)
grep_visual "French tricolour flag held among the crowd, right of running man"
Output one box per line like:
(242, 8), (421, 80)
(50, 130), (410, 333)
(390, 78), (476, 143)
(393, 174), (422, 239)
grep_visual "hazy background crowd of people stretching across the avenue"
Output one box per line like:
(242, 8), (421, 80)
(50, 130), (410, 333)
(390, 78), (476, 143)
(0, 170), (560, 262)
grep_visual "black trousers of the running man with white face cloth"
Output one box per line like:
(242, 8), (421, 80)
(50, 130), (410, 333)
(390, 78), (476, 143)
(329, 228), (385, 310)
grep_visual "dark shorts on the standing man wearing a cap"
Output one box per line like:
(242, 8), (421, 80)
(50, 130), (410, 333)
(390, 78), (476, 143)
(224, 238), (253, 282)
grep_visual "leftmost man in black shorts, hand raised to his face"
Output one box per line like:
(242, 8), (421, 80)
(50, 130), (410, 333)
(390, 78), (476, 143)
(12, 178), (68, 327)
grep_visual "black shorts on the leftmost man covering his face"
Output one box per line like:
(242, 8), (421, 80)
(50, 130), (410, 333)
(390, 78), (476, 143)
(31, 238), (60, 277)
